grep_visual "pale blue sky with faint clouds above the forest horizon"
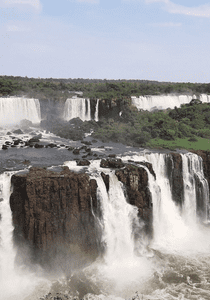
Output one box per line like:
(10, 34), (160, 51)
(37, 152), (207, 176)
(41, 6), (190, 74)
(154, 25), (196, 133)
(0, 0), (210, 83)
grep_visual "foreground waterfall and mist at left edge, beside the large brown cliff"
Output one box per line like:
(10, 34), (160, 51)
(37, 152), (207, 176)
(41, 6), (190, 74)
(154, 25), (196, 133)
(0, 172), (49, 300)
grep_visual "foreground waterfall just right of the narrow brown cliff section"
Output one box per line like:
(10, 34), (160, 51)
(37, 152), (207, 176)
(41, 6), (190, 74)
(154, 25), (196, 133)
(144, 153), (187, 248)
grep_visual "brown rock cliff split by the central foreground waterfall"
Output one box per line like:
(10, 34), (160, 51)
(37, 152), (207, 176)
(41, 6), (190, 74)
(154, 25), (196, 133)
(10, 164), (152, 264)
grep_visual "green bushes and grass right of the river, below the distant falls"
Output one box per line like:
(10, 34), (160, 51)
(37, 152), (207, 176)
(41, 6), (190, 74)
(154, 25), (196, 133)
(94, 100), (210, 150)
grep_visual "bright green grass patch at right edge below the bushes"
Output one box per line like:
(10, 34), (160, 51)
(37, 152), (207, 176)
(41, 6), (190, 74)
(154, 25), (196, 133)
(146, 137), (210, 151)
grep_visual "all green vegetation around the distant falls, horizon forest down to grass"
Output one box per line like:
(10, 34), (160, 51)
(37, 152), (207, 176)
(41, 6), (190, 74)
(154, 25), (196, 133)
(0, 76), (210, 150)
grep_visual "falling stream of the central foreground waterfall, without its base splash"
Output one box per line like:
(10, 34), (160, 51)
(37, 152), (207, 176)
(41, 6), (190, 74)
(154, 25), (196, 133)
(97, 173), (138, 263)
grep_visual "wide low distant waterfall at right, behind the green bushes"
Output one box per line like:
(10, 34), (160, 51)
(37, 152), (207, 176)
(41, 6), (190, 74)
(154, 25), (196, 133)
(131, 94), (210, 111)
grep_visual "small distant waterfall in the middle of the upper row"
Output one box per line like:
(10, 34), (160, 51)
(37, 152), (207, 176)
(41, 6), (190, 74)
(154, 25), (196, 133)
(64, 97), (91, 121)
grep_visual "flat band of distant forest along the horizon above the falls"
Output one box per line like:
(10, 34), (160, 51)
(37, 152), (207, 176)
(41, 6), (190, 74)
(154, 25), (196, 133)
(0, 76), (210, 100)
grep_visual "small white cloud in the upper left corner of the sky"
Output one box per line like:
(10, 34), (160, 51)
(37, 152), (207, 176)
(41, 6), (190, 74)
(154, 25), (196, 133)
(0, 0), (42, 12)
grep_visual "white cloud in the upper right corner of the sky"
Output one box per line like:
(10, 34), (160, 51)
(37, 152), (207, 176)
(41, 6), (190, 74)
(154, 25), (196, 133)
(145, 0), (210, 18)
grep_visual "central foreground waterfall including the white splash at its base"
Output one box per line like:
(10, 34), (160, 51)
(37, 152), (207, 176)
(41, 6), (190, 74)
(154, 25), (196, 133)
(94, 171), (151, 290)
